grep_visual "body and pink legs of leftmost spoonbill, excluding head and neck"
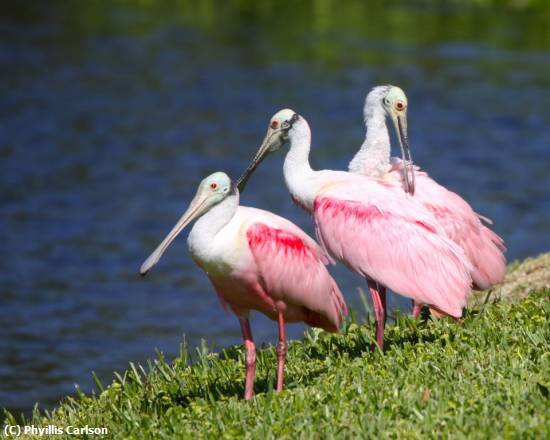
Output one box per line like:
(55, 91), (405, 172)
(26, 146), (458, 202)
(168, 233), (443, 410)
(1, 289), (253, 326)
(193, 207), (347, 399)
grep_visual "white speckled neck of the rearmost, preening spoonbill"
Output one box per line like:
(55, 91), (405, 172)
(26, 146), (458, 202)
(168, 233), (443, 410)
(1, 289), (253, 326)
(348, 99), (390, 178)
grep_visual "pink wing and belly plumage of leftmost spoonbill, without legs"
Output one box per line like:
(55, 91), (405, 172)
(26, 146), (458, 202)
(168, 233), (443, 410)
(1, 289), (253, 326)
(205, 220), (347, 332)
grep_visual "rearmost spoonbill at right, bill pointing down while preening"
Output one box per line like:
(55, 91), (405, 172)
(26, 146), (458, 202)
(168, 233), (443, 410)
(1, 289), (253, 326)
(349, 85), (506, 316)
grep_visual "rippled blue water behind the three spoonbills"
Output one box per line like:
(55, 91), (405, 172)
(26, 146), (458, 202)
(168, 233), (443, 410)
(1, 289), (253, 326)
(0, 1), (550, 412)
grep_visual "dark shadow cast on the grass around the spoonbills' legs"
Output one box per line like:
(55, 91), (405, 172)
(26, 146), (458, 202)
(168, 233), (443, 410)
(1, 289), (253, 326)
(142, 309), (492, 412)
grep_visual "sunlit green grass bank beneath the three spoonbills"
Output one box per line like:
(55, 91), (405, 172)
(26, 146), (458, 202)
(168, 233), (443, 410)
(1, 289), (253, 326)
(6, 289), (550, 439)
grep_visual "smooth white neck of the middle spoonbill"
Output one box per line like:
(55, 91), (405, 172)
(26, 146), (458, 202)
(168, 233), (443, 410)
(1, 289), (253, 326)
(283, 117), (316, 210)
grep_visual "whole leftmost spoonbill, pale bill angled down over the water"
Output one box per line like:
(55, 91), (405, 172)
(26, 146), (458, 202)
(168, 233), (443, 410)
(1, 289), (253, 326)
(140, 172), (347, 399)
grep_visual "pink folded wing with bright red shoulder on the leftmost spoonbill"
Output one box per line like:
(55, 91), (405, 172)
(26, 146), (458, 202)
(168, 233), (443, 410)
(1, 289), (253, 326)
(246, 223), (347, 331)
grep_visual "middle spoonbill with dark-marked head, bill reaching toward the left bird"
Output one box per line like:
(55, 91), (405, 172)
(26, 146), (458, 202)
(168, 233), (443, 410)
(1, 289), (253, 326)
(239, 109), (472, 348)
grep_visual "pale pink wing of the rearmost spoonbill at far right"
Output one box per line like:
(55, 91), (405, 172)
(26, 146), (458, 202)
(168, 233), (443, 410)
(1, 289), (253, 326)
(390, 158), (506, 289)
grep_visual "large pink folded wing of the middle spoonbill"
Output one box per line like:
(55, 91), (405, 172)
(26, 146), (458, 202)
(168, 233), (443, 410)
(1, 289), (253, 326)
(313, 185), (472, 317)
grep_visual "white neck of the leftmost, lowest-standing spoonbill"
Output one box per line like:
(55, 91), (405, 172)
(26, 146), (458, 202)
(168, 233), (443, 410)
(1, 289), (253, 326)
(187, 191), (239, 256)
